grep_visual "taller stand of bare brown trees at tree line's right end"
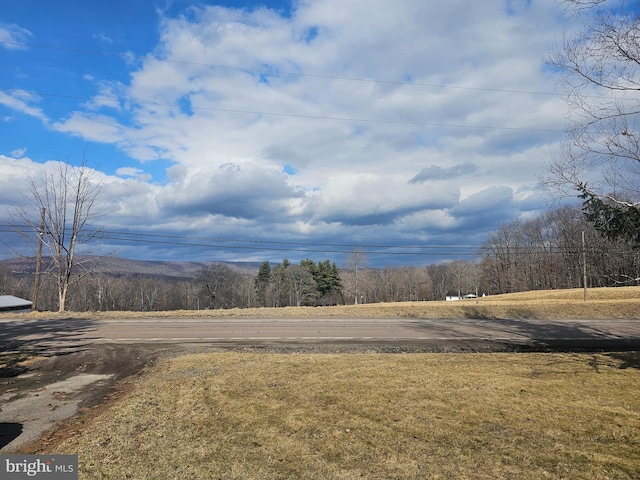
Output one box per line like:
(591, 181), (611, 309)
(480, 206), (640, 294)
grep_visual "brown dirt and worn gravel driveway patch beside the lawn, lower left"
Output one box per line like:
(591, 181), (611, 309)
(0, 344), (185, 453)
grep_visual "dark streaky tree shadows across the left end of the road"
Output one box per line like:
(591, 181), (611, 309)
(0, 317), (95, 378)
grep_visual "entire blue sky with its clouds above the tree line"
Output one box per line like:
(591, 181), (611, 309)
(0, 0), (571, 265)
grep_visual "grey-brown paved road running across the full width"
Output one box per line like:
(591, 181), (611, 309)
(0, 316), (640, 350)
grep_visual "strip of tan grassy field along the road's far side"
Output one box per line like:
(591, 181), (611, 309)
(20, 287), (640, 319)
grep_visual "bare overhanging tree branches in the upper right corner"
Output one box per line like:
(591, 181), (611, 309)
(542, 0), (640, 209)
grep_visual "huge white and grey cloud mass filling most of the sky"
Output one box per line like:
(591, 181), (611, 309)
(0, 0), (576, 262)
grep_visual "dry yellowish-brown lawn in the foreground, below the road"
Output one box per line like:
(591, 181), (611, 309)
(51, 352), (640, 480)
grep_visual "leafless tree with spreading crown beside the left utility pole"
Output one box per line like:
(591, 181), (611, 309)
(10, 159), (105, 311)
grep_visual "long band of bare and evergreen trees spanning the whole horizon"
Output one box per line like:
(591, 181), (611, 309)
(0, 203), (640, 311)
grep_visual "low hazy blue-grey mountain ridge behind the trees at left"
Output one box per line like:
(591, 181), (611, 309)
(0, 256), (259, 278)
